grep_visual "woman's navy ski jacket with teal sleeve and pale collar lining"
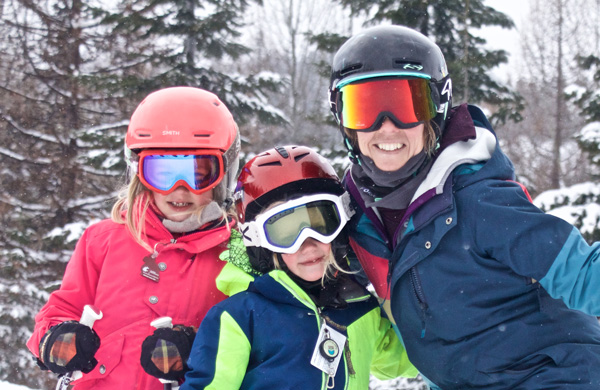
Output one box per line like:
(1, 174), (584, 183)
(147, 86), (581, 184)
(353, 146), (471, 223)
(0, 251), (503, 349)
(345, 107), (600, 390)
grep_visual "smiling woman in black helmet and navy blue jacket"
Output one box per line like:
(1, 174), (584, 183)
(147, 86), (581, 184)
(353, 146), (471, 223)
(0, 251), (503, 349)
(330, 26), (600, 390)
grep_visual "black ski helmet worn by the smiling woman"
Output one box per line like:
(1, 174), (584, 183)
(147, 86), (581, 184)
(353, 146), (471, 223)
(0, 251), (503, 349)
(329, 25), (452, 159)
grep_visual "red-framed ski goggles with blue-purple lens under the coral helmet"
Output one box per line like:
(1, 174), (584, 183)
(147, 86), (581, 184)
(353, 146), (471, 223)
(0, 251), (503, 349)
(138, 149), (225, 195)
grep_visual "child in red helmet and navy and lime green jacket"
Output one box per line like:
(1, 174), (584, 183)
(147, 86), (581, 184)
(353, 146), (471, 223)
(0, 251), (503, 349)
(181, 146), (416, 390)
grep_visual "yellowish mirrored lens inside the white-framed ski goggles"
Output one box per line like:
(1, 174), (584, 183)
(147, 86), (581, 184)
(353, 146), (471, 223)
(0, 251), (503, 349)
(264, 200), (341, 248)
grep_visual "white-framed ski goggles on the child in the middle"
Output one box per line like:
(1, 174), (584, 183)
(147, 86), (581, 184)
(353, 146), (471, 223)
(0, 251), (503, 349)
(240, 193), (354, 254)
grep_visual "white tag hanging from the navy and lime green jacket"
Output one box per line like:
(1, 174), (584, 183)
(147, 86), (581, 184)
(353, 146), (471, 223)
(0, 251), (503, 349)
(310, 323), (346, 379)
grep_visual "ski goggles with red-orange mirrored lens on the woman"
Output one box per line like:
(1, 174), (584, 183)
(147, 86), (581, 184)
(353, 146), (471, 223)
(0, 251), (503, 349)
(336, 78), (437, 131)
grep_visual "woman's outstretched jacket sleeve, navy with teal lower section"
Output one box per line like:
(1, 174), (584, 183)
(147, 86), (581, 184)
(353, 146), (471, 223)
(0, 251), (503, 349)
(468, 180), (600, 315)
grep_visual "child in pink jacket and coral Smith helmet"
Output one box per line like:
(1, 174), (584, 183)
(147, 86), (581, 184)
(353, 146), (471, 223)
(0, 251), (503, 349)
(27, 87), (251, 389)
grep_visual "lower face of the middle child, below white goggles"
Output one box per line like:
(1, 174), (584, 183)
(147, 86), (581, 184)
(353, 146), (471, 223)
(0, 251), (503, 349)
(281, 238), (331, 282)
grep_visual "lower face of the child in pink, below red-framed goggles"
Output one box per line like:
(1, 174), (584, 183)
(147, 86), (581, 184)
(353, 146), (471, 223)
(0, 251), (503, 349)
(152, 186), (213, 222)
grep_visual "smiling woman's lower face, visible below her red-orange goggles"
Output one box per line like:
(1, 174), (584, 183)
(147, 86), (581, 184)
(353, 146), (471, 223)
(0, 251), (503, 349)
(356, 118), (425, 172)
